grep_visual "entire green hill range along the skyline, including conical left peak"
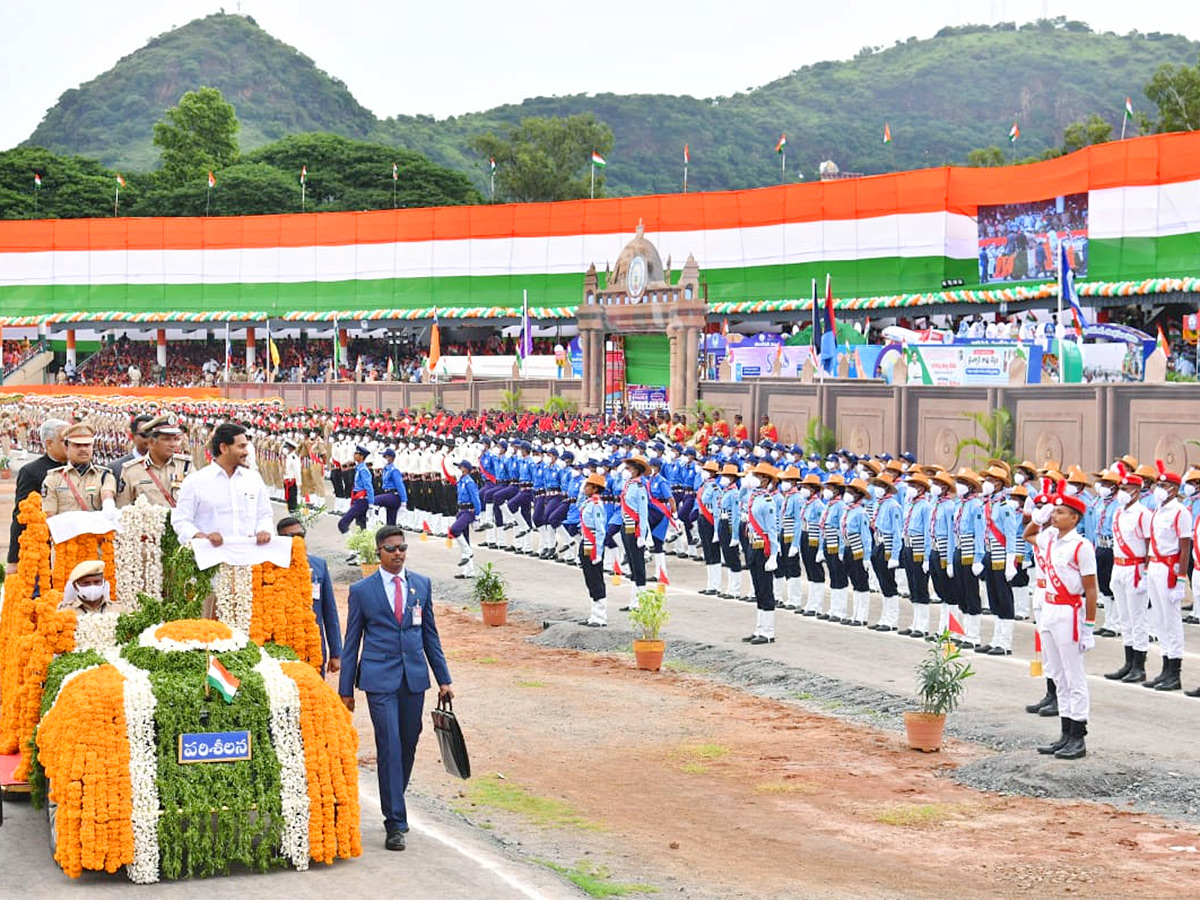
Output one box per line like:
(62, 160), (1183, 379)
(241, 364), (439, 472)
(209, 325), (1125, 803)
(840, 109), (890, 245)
(18, 14), (1200, 196)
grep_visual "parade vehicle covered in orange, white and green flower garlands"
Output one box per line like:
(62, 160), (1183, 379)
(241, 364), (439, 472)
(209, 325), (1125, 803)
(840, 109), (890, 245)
(0, 493), (361, 883)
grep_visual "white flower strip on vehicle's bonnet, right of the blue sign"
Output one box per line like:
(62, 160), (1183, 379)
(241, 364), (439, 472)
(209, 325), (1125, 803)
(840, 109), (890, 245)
(254, 653), (310, 871)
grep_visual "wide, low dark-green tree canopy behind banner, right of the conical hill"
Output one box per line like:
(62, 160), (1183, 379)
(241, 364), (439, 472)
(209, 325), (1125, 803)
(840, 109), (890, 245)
(244, 134), (484, 211)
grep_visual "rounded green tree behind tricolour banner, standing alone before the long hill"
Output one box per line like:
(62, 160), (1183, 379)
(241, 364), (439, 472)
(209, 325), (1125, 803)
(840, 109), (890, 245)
(472, 113), (612, 203)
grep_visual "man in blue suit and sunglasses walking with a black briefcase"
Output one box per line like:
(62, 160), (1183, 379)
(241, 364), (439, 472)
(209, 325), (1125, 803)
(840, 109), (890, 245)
(337, 526), (454, 850)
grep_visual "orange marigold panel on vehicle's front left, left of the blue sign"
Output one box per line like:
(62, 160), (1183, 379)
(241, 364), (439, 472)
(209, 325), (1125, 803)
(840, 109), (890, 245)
(37, 665), (133, 878)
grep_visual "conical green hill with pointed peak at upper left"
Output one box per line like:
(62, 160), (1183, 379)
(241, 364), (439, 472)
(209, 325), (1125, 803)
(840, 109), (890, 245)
(25, 14), (376, 172)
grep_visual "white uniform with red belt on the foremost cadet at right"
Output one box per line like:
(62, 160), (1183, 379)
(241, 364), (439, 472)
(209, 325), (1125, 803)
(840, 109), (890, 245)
(1037, 527), (1096, 721)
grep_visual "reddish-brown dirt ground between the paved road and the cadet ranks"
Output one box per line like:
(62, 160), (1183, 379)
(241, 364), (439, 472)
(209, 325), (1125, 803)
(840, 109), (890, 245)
(358, 606), (1200, 898)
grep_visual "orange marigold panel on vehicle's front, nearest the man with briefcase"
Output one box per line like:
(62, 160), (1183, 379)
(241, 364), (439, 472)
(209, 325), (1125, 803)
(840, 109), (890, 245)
(280, 661), (362, 863)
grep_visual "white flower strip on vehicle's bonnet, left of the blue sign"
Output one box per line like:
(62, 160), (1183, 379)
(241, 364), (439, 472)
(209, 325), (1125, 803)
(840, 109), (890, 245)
(104, 649), (158, 884)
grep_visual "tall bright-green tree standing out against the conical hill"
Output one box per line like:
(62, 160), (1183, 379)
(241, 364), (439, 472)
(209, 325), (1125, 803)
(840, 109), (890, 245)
(154, 88), (239, 185)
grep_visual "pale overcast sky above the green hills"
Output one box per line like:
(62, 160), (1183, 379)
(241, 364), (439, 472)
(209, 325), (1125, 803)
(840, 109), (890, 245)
(0, 0), (1200, 148)
